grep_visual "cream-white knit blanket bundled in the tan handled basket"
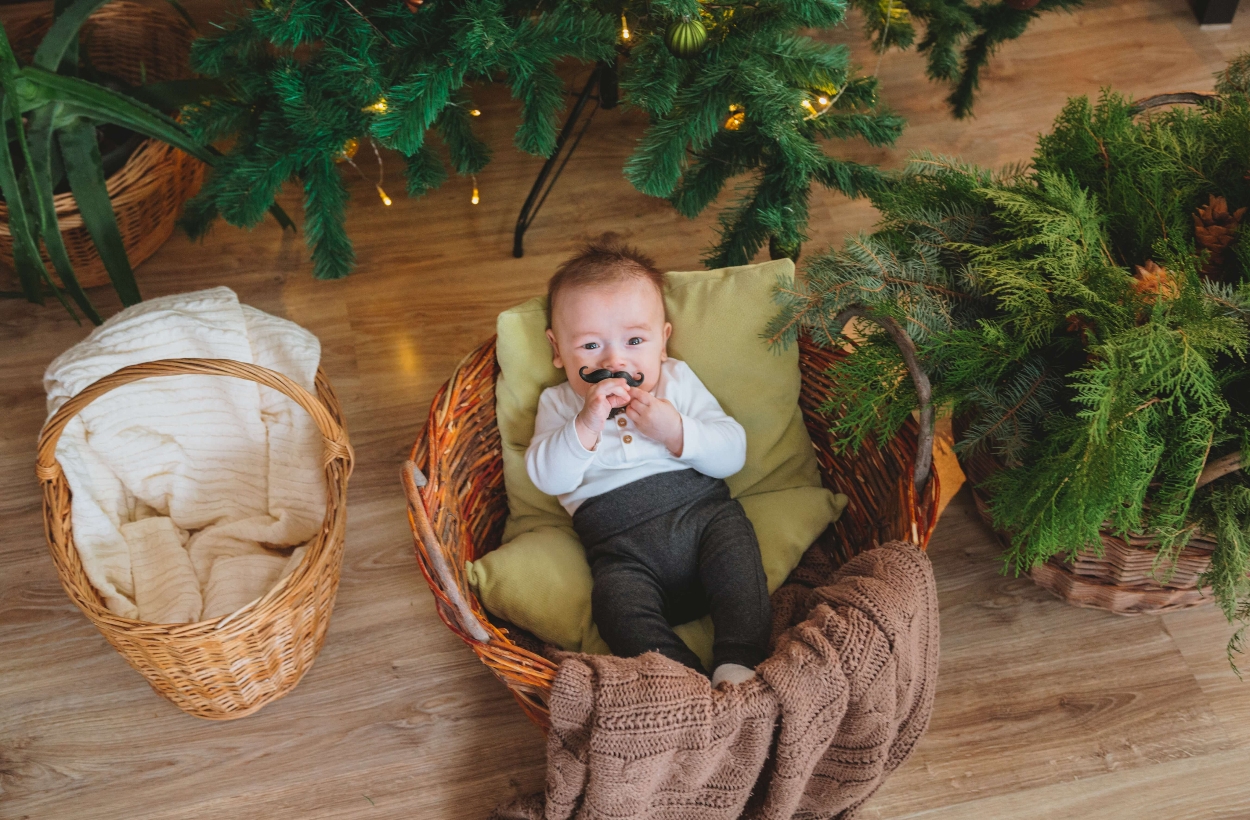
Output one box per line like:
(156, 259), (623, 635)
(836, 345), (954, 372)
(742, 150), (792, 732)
(44, 288), (325, 624)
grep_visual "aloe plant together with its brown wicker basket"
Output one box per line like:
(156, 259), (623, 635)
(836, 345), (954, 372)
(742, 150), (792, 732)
(0, 0), (227, 323)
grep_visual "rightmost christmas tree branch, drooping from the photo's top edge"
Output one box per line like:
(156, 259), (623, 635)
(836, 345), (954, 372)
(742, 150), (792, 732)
(851, 0), (1084, 119)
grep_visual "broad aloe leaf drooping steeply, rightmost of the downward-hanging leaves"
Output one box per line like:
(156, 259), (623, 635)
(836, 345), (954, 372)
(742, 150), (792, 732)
(56, 120), (144, 308)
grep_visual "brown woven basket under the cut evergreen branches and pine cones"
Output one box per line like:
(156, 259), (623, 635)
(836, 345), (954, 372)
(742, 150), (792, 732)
(955, 420), (1215, 615)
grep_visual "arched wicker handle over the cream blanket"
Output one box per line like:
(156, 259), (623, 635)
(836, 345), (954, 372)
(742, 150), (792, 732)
(35, 359), (355, 483)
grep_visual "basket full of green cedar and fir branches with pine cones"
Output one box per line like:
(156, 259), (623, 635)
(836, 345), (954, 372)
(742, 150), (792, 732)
(773, 55), (1250, 660)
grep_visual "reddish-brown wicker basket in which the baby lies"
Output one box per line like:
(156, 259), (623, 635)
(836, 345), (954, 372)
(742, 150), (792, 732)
(404, 339), (939, 730)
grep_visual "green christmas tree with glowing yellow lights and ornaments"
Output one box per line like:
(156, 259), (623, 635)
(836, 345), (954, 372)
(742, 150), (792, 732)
(178, 0), (1085, 279)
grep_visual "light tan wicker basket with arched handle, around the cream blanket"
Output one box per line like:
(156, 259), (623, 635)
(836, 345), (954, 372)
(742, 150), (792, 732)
(36, 359), (353, 720)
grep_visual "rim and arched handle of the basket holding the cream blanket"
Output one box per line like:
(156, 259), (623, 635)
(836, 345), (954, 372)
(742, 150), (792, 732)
(36, 359), (355, 630)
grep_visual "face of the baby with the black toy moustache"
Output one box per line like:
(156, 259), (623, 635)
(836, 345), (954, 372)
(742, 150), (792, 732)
(548, 279), (673, 398)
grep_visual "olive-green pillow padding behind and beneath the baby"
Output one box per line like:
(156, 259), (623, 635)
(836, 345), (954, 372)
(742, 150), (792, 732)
(468, 259), (846, 664)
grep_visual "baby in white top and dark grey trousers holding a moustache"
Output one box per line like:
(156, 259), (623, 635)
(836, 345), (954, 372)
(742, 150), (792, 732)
(525, 243), (771, 686)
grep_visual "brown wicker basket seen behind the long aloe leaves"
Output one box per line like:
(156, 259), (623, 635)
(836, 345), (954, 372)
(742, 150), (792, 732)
(0, 0), (205, 288)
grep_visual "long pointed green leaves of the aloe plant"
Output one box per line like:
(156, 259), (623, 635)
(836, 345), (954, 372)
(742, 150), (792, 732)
(0, 0), (291, 324)
